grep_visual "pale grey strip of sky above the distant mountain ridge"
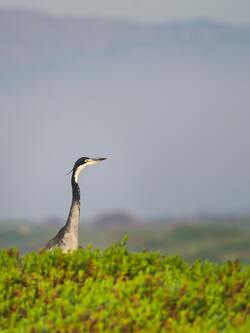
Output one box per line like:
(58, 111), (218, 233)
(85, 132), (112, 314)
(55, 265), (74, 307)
(0, 0), (250, 24)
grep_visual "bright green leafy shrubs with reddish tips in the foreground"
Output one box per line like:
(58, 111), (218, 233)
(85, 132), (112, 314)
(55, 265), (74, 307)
(0, 239), (250, 333)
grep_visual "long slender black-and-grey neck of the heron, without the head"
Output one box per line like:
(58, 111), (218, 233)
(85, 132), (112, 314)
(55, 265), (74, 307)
(66, 173), (80, 233)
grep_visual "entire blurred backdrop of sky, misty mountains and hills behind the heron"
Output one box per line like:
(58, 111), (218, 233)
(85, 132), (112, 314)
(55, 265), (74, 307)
(0, 0), (250, 262)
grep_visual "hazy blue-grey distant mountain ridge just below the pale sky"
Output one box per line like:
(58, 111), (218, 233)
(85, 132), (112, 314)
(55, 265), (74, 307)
(0, 10), (250, 74)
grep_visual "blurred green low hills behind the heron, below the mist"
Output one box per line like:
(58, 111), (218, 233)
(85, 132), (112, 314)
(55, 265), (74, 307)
(0, 213), (250, 263)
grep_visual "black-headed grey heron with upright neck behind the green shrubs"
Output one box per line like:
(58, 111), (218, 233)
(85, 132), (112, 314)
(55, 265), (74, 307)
(44, 157), (106, 252)
